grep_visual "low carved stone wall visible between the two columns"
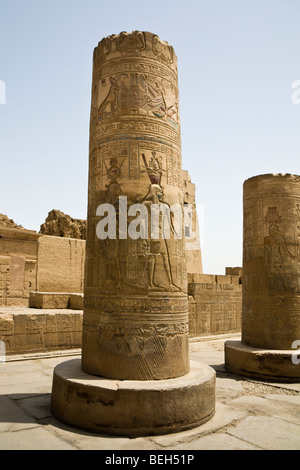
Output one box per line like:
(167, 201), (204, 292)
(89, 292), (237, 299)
(188, 274), (242, 337)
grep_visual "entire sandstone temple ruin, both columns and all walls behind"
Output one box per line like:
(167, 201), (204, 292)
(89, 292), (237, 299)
(0, 31), (300, 444)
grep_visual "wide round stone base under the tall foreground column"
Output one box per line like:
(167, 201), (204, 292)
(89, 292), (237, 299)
(51, 359), (216, 437)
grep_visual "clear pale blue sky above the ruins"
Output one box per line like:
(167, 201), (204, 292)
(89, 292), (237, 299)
(0, 0), (300, 274)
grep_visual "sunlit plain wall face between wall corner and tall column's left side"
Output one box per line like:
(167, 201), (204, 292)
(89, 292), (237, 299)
(38, 235), (85, 293)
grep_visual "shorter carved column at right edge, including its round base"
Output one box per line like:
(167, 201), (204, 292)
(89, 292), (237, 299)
(225, 174), (300, 381)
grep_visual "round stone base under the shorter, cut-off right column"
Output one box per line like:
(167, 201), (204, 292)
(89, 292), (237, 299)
(225, 341), (300, 382)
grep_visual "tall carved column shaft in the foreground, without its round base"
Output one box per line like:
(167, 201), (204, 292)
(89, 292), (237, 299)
(82, 31), (189, 380)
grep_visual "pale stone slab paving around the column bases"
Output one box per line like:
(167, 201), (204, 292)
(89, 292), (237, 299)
(0, 335), (300, 452)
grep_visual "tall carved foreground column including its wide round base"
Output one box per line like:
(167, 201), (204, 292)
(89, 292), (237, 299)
(52, 31), (215, 435)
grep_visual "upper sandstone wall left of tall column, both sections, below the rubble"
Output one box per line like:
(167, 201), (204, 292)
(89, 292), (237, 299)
(0, 228), (85, 307)
